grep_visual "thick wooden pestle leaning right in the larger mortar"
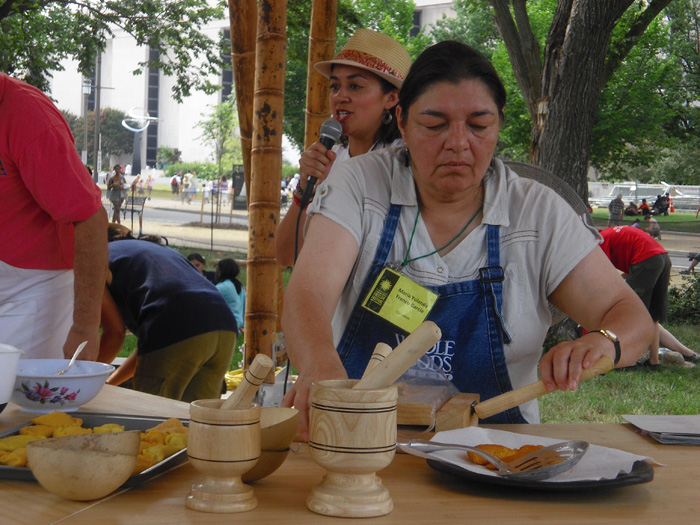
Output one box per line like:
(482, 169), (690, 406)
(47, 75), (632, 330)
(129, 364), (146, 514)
(352, 321), (442, 390)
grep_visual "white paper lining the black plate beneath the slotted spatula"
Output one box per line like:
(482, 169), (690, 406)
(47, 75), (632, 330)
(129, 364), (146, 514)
(399, 427), (660, 482)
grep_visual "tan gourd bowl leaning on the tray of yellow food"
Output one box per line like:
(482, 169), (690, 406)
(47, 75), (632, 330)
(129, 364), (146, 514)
(27, 431), (141, 501)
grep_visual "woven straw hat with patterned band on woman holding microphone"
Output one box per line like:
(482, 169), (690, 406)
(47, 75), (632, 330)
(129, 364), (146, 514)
(314, 29), (411, 88)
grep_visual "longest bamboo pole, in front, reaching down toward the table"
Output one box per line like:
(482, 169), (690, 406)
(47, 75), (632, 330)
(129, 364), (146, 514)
(245, 0), (287, 374)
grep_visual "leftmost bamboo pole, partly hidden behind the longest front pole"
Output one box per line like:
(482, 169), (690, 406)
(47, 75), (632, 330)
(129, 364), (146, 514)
(228, 0), (257, 209)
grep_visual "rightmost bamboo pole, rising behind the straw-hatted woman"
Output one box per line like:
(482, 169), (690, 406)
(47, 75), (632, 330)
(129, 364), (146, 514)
(304, 0), (338, 149)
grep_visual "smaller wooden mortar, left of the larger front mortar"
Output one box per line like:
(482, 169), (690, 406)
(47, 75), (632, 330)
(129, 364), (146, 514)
(185, 399), (260, 513)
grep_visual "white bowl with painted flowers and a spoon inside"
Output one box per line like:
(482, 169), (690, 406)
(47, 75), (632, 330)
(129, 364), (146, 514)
(10, 359), (114, 414)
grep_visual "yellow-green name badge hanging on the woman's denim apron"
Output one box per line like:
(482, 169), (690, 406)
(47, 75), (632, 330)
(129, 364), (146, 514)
(362, 268), (438, 333)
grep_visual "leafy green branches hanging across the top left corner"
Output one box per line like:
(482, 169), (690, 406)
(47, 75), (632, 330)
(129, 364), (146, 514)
(0, 0), (228, 100)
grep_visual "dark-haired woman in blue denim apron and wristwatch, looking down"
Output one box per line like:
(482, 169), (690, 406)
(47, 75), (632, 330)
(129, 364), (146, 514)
(282, 41), (653, 435)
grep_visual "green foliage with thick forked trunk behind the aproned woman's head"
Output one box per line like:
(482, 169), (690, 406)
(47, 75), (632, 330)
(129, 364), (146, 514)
(426, 0), (698, 198)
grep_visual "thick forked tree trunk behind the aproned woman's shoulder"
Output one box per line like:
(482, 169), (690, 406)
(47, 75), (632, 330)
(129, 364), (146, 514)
(489, 0), (671, 202)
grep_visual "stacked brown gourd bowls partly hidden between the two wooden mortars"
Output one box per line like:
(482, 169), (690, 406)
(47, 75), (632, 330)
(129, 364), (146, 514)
(243, 407), (299, 483)
